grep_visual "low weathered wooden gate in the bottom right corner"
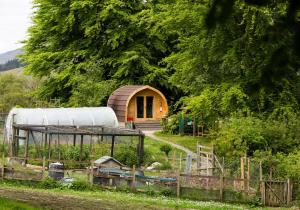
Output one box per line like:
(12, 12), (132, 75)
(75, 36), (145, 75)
(261, 180), (292, 206)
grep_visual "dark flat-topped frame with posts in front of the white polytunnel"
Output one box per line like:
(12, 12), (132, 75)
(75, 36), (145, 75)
(9, 124), (145, 167)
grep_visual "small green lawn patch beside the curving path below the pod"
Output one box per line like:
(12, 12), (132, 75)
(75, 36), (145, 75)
(155, 131), (211, 152)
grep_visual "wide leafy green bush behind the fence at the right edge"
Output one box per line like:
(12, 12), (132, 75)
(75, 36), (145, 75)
(213, 116), (300, 157)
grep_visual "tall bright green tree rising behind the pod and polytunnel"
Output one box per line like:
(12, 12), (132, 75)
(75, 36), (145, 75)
(23, 0), (176, 106)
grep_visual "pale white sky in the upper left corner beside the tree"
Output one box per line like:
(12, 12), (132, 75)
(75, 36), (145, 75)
(0, 0), (32, 53)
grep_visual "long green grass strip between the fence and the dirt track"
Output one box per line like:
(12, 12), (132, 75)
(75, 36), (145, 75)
(0, 183), (283, 210)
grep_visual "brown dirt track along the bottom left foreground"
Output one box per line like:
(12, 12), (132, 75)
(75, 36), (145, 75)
(0, 188), (170, 210)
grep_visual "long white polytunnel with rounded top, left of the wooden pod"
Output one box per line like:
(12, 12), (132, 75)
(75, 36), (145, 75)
(5, 107), (119, 141)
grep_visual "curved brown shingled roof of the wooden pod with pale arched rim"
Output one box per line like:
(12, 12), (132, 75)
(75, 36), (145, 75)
(107, 85), (167, 122)
